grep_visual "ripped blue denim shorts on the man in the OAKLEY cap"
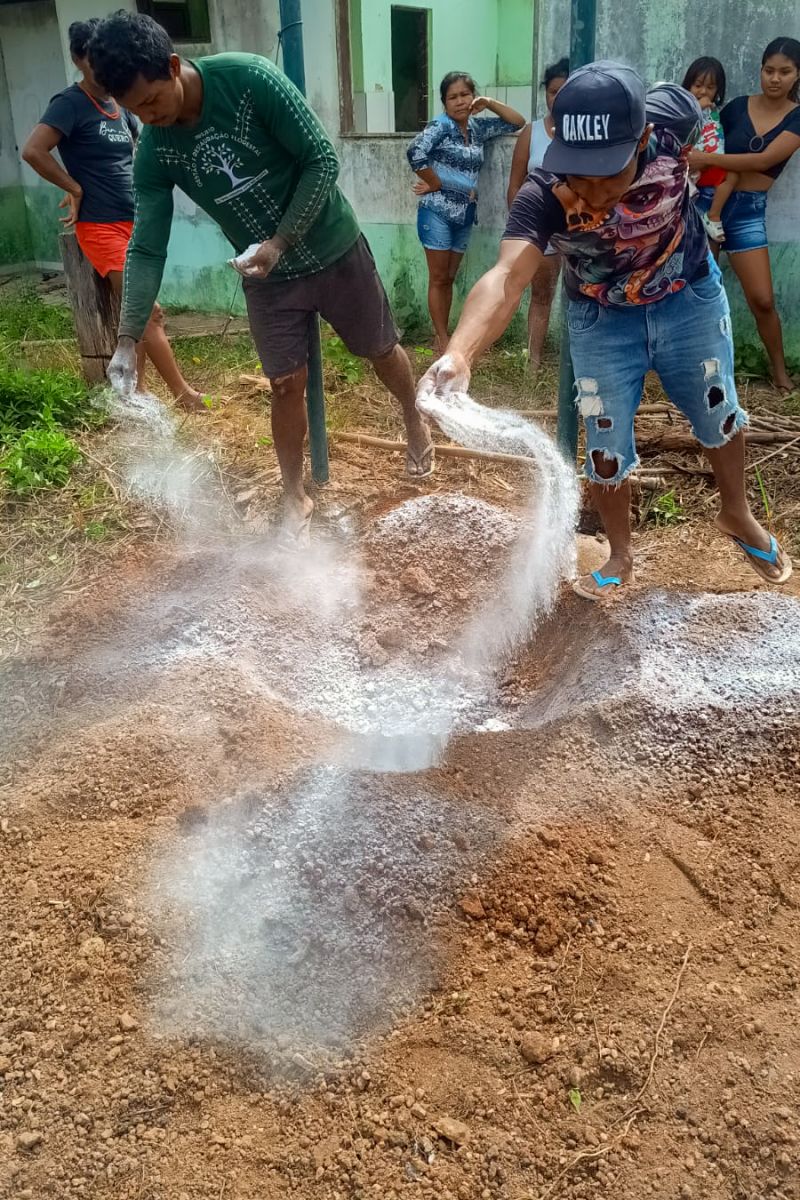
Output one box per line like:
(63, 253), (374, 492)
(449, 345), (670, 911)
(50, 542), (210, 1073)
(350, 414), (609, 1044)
(567, 257), (747, 486)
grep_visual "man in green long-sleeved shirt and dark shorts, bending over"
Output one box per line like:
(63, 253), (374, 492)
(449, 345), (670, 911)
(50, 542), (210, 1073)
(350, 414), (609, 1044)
(89, 12), (433, 535)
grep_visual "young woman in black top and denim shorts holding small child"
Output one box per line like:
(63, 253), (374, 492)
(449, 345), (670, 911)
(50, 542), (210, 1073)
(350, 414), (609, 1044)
(688, 37), (800, 391)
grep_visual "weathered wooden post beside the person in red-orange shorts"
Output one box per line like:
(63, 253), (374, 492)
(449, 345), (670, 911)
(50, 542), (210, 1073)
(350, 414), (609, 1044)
(59, 230), (120, 383)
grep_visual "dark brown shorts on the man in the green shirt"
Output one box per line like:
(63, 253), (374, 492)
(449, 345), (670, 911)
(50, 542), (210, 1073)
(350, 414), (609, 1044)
(242, 234), (399, 379)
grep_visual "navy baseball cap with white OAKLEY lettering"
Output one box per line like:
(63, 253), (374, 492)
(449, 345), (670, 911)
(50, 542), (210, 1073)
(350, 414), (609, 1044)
(542, 62), (648, 178)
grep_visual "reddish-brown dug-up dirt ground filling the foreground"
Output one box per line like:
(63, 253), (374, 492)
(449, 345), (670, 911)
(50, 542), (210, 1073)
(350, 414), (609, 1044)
(0, 376), (800, 1200)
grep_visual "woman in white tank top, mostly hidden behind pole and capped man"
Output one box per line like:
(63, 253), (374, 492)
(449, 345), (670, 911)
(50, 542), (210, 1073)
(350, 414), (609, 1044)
(509, 59), (570, 371)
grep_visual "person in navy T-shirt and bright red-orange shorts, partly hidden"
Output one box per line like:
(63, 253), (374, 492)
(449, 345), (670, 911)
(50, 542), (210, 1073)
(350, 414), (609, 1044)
(22, 17), (205, 412)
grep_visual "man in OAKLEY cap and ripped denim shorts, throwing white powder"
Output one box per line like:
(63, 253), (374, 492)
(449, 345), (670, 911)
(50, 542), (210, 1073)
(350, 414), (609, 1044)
(417, 62), (792, 600)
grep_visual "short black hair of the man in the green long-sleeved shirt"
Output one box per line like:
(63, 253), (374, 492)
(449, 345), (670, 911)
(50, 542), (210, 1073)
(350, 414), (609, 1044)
(89, 10), (175, 97)
